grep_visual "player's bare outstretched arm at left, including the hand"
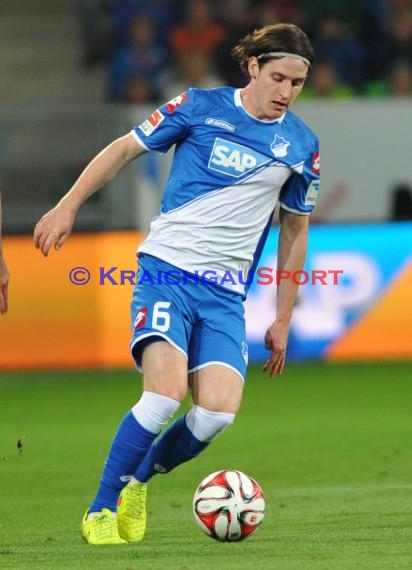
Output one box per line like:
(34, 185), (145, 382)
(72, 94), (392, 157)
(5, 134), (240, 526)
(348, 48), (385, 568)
(34, 133), (146, 257)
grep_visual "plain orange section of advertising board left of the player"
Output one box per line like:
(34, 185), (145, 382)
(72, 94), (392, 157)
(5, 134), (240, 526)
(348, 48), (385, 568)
(0, 232), (143, 370)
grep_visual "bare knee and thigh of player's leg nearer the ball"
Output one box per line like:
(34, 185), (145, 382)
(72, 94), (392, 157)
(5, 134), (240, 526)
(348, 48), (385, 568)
(189, 364), (243, 414)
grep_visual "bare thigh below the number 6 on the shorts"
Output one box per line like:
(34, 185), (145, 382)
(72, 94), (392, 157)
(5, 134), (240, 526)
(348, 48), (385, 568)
(142, 340), (188, 402)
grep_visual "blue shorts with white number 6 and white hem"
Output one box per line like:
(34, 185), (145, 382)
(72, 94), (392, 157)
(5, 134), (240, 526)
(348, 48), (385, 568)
(130, 254), (248, 380)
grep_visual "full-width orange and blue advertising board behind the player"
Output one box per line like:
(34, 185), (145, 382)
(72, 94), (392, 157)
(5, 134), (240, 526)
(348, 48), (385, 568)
(0, 223), (412, 371)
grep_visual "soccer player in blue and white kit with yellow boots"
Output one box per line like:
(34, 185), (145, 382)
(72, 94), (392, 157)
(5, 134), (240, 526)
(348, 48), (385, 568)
(34, 24), (319, 544)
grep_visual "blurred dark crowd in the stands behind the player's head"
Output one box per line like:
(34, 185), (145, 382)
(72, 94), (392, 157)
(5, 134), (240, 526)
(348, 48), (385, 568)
(79, 0), (412, 103)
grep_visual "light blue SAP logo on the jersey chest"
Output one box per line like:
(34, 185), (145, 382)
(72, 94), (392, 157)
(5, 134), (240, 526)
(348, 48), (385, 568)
(208, 138), (271, 178)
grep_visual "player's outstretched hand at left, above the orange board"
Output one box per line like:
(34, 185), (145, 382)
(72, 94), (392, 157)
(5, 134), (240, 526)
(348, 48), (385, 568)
(33, 204), (75, 257)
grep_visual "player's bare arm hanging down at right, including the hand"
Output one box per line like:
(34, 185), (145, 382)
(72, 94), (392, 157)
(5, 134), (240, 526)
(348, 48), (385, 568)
(263, 207), (309, 376)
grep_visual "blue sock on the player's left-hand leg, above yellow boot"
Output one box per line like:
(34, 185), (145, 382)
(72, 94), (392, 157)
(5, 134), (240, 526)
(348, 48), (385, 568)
(89, 412), (157, 513)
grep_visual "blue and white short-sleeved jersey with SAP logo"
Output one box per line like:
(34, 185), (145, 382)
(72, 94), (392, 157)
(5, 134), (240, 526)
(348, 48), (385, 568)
(132, 87), (319, 294)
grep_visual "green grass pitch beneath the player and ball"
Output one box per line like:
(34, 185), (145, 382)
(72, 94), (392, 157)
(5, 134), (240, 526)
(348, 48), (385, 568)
(0, 363), (412, 570)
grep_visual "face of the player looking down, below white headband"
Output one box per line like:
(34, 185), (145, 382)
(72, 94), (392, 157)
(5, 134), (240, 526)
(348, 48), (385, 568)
(248, 57), (308, 121)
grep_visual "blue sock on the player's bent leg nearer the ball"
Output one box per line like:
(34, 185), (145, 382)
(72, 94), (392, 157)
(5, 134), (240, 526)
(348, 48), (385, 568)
(135, 410), (209, 483)
